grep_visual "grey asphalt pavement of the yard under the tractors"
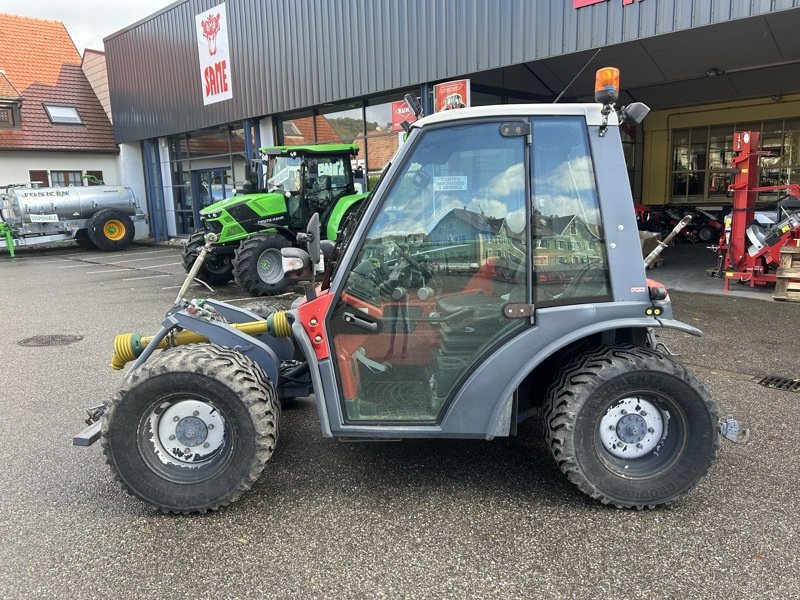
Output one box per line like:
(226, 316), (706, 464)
(0, 244), (800, 599)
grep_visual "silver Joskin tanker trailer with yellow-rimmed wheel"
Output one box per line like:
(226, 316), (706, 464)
(0, 185), (145, 256)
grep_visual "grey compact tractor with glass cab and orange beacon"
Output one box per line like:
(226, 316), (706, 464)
(74, 69), (745, 513)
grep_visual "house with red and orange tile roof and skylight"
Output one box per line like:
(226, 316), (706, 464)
(0, 14), (124, 186)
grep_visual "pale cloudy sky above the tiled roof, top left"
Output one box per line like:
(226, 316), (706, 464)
(0, 0), (174, 54)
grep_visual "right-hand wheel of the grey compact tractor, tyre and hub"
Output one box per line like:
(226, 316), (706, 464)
(544, 346), (719, 509)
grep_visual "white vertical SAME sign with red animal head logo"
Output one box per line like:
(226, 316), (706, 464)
(195, 2), (233, 105)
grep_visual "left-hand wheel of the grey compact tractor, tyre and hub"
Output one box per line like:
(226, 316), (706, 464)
(101, 344), (280, 513)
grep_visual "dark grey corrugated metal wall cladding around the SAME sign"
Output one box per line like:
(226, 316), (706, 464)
(104, 0), (800, 142)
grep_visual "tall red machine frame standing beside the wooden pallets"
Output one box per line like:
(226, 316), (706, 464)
(719, 131), (800, 291)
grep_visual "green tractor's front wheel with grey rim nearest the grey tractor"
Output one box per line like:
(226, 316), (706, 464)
(233, 233), (292, 296)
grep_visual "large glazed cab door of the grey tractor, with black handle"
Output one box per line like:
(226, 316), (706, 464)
(327, 120), (532, 426)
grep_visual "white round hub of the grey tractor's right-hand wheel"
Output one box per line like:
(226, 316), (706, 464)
(599, 396), (669, 458)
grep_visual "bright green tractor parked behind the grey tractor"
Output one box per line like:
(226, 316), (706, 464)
(183, 144), (366, 296)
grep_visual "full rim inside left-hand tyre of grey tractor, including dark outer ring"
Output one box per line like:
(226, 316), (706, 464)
(139, 398), (230, 482)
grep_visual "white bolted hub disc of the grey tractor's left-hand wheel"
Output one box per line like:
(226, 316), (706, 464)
(150, 400), (225, 467)
